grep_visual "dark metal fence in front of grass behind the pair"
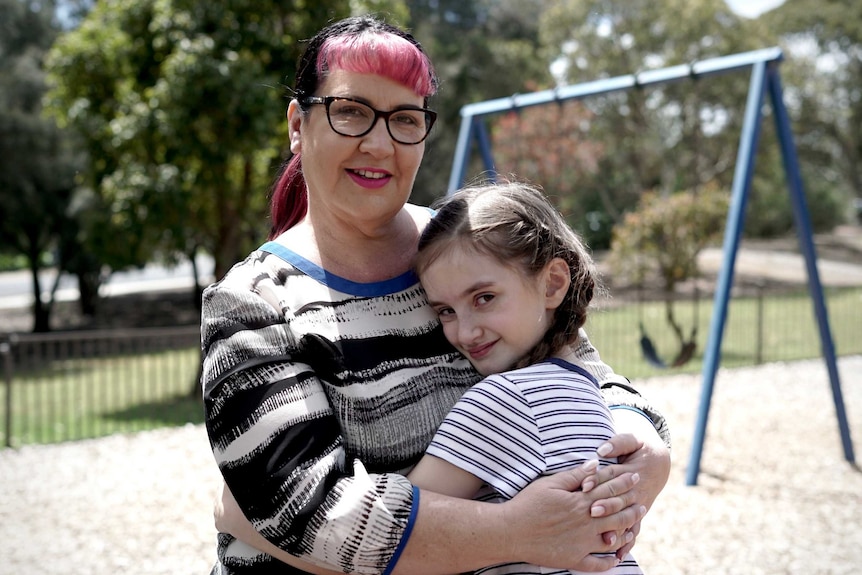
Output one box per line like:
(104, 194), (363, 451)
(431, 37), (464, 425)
(0, 287), (862, 446)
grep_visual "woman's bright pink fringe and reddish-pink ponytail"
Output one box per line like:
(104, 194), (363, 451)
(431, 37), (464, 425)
(269, 23), (437, 239)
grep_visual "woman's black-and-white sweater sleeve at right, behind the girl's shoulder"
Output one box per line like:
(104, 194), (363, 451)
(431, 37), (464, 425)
(575, 329), (671, 449)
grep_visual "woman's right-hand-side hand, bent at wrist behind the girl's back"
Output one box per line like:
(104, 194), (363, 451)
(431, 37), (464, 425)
(584, 409), (671, 558)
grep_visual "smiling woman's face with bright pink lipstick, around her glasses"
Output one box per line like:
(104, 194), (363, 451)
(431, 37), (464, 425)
(288, 70), (425, 233)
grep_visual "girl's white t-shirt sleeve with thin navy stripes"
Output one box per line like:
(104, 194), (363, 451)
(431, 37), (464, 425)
(426, 376), (545, 498)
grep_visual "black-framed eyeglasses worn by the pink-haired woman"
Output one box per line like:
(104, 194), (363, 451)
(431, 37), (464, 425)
(299, 96), (437, 145)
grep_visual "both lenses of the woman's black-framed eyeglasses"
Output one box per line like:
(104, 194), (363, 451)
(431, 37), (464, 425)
(328, 99), (429, 144)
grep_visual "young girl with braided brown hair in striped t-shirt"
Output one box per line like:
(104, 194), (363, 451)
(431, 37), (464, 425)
(408, 183), (642, 575)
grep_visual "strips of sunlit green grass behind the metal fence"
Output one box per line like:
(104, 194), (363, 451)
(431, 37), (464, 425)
(0, 288), (862, 446)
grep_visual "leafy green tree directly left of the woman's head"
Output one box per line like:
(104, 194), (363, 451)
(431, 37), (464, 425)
(49, 0), (349, 286)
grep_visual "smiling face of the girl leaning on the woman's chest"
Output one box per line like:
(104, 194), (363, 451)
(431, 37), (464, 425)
(420, 243), (569, 376)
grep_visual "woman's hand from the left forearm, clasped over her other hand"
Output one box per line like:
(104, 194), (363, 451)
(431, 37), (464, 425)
(501, 461), (646, 571)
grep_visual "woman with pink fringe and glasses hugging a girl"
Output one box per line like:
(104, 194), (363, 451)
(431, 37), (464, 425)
(202, 13), (670, 574)
